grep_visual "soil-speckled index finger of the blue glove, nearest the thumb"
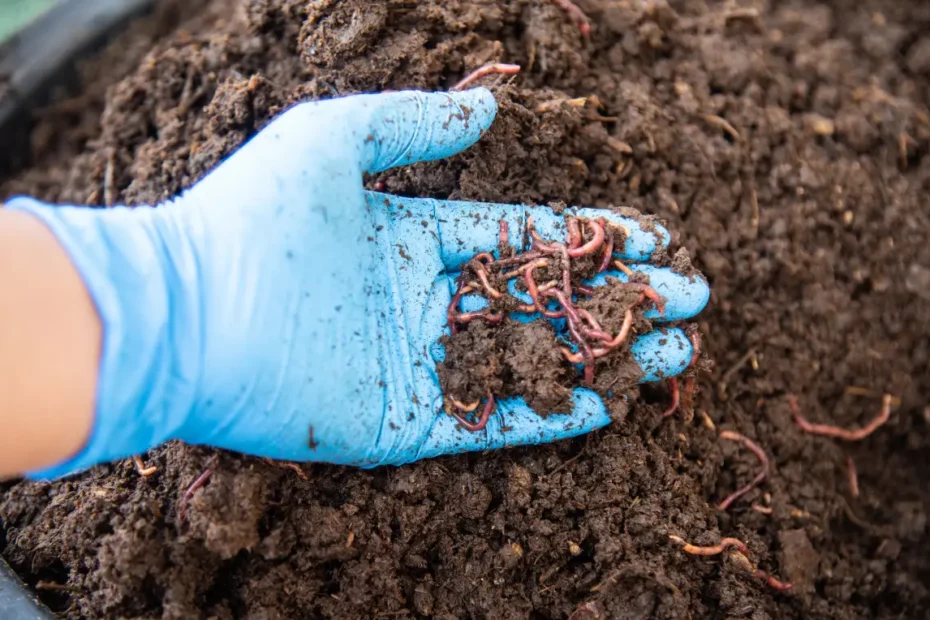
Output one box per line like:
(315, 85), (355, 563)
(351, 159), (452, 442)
(418, 198), (671, 270)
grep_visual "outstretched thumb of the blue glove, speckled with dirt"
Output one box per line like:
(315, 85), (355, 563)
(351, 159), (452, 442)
(358, 88), (497, 173)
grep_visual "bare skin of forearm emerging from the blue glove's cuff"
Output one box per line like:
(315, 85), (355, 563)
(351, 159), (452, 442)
(0, 209), (102, 479)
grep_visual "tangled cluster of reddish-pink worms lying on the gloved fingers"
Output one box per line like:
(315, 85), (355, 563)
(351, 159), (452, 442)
(446, 216), (665, 432)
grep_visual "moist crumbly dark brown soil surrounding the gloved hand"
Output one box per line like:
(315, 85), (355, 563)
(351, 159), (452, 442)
(0, 0), (930, 620)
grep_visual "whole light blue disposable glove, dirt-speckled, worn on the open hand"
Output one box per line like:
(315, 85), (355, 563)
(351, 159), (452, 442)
(8, 89), (709, 477)
